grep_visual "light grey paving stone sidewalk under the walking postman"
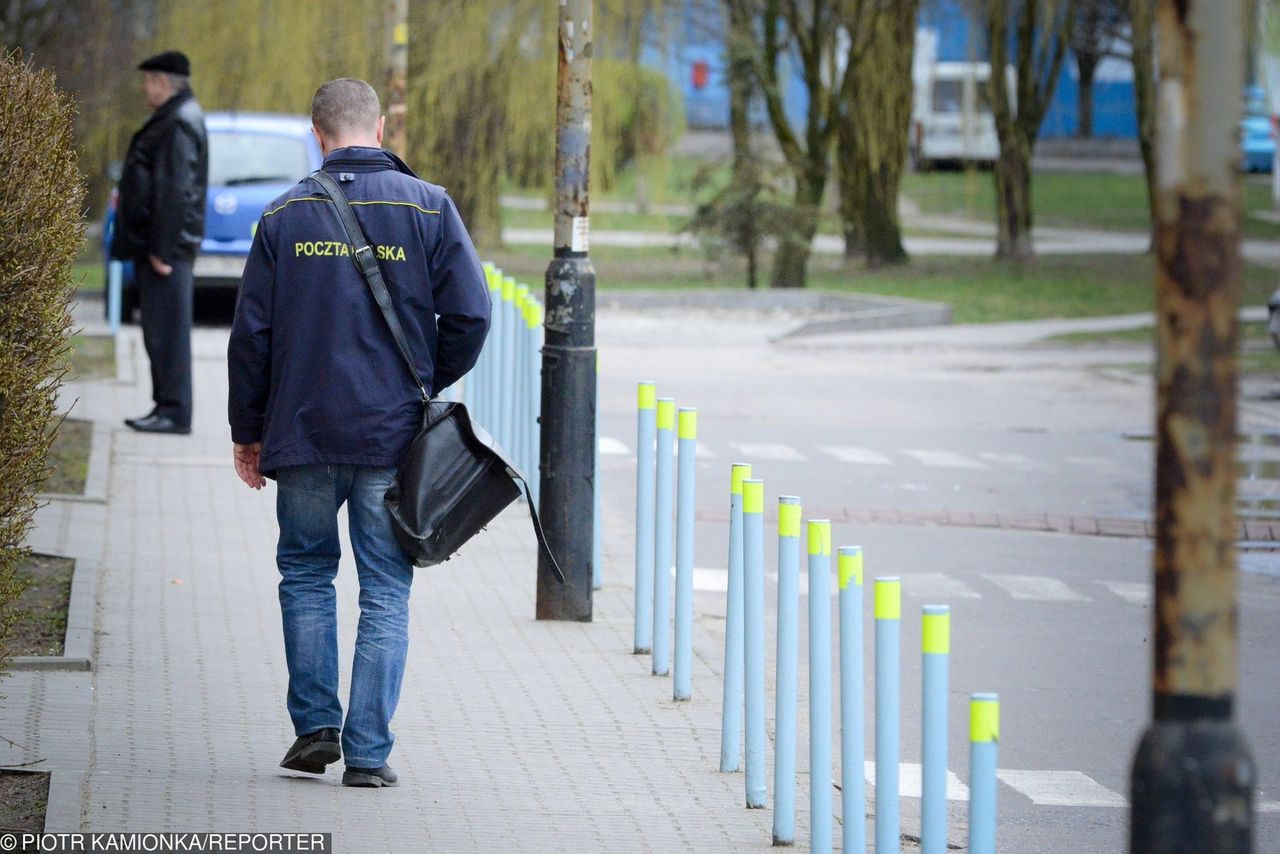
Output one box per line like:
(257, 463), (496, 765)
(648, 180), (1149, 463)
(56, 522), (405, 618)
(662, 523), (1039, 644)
(0, 323), (808, 853)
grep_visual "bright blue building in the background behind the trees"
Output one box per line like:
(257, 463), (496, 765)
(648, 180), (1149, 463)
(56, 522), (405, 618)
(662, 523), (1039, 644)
(645, 0), (1138, 140)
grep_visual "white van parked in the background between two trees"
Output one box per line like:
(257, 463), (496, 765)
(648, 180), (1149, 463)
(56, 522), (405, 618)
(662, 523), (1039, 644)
(910, 63), (1012, 170)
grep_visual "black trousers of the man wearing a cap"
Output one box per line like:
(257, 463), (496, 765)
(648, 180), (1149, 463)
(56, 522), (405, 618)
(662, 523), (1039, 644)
(133, 253), (195, 428)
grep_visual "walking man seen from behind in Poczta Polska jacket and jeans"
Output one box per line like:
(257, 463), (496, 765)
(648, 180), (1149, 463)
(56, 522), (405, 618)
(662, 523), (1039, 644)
(228, 78), (490, 787)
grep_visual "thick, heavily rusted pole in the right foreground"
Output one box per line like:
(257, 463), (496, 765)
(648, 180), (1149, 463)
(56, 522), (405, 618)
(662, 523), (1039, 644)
(1129, 0), (1254, 854)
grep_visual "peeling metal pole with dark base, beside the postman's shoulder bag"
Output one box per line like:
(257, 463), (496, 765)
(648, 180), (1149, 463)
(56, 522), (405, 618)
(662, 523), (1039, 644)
(536, 0), (595, 621)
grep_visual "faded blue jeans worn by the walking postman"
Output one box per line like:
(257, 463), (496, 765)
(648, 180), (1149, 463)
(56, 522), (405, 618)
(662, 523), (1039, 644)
(275, 465), (413, 768)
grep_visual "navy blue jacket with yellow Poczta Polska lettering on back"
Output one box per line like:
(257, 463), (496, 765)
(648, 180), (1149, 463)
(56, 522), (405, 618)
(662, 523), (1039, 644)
(227, 147), (490, 472)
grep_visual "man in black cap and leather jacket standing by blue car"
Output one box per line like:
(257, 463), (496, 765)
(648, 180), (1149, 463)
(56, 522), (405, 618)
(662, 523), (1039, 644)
(111, 50), (209, 433)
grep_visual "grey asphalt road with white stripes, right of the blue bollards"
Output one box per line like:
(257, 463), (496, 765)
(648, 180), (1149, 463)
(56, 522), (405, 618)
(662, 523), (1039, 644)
(598, 303), (1280, 853)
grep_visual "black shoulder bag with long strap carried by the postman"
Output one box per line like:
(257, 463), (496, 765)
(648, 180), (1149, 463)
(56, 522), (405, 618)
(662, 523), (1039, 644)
(311, 170), (564, 583)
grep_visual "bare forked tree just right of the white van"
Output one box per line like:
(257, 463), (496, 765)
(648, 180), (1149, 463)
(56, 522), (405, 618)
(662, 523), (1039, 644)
(982, 0), (1074, 260)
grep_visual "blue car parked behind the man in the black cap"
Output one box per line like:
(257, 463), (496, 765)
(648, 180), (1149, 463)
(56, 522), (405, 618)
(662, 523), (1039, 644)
(102, 113), (323, 320)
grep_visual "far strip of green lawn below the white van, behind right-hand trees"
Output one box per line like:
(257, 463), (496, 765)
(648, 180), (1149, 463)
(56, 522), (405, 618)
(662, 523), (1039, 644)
(902, 170), (1280, 238)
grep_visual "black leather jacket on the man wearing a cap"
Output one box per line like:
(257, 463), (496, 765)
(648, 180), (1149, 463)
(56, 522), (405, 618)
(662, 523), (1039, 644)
(111, 90), (209, 264)
